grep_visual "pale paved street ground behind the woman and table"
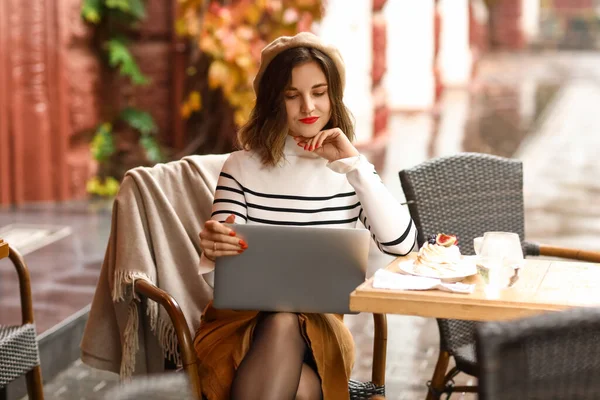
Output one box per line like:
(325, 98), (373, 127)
(7, 54), (600, 400)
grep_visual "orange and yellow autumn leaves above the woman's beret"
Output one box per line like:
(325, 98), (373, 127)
(176, 0), (323, 127)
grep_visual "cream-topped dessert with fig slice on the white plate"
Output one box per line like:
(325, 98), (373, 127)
(414, 233), (462, 277)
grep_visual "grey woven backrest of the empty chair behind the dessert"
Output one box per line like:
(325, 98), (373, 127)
(400, 153), (525, 254)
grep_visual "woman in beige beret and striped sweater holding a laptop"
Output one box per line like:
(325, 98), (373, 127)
(194, 32), (416, 400)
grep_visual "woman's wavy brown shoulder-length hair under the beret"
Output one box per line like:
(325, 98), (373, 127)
(238, 47), (354, 166)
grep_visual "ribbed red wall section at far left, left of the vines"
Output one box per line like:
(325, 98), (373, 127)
(0, 0), (70, 204)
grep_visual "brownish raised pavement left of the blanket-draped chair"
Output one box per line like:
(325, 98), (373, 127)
(0, 202), (110, 335)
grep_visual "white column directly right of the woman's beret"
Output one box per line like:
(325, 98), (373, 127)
(315, 0), (373, 145)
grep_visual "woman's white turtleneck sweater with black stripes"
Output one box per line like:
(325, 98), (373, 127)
(200, 137), (417, 273)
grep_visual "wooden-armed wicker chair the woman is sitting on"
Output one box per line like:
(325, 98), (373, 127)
(125, 157), (387, 400)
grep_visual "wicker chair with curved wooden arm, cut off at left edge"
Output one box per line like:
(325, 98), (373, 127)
(0, 239), (44, 400)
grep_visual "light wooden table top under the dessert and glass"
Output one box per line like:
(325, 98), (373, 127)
(350, 254), (600, 321)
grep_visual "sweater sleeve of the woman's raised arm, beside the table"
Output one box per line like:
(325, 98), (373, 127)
(328, 155), (417, 256)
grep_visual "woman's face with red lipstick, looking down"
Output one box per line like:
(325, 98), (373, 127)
(283, 61), (331, 138)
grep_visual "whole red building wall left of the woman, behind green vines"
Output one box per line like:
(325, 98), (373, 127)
(0, 0), (174, 205)
